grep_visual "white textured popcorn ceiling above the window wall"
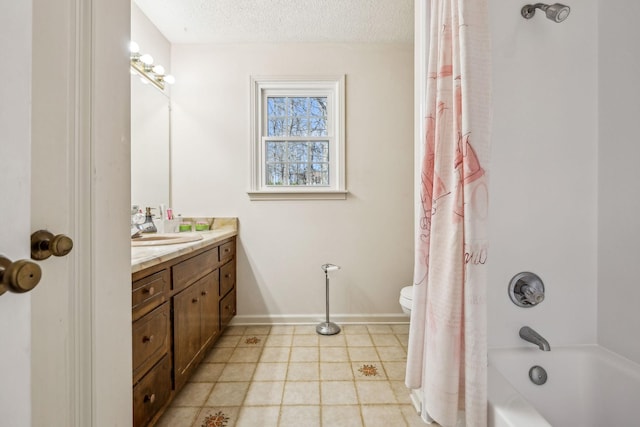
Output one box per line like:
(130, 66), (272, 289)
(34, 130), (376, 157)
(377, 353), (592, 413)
(134, 0), (414, 43)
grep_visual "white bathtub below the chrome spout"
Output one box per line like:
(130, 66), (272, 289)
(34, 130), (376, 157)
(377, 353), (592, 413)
(488, 346), (640, 427)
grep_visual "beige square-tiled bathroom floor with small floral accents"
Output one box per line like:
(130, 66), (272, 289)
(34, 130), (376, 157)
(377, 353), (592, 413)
(157, 325), (425, 427)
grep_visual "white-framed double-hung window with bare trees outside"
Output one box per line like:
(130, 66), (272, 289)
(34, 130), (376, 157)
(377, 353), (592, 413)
(249, 76), (346, 200)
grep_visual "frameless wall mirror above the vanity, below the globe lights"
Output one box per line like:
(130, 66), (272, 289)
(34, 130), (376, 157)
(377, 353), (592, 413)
(131, 74), (171, 209)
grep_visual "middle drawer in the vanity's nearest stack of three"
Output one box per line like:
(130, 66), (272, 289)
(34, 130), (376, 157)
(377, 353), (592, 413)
(132, 303), (171, 383)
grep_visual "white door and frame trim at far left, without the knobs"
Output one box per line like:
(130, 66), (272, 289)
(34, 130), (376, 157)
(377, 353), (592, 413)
(0, 0), (132, 427)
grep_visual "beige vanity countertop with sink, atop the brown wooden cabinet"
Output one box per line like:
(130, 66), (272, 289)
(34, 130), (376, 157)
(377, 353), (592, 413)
(131, 218), (238, 273)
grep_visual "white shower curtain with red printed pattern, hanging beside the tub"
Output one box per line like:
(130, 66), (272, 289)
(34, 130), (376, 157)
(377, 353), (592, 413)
(405, 0), (491, 427)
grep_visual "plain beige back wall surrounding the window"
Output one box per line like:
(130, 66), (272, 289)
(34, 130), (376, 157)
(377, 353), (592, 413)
(171, 44), (413, 321)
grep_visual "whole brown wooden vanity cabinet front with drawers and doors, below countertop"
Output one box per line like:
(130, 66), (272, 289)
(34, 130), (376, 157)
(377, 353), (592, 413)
(132, 237), (236, 427)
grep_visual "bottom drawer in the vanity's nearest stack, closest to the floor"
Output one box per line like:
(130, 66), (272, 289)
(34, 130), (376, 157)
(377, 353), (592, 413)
(133, 355), (171, 427)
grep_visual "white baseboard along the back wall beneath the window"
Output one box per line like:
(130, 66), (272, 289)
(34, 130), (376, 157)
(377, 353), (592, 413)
(230, 313), (409, 326)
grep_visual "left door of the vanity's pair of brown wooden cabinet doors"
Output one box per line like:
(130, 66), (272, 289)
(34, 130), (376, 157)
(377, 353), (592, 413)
(173, 283), (202, 389)
